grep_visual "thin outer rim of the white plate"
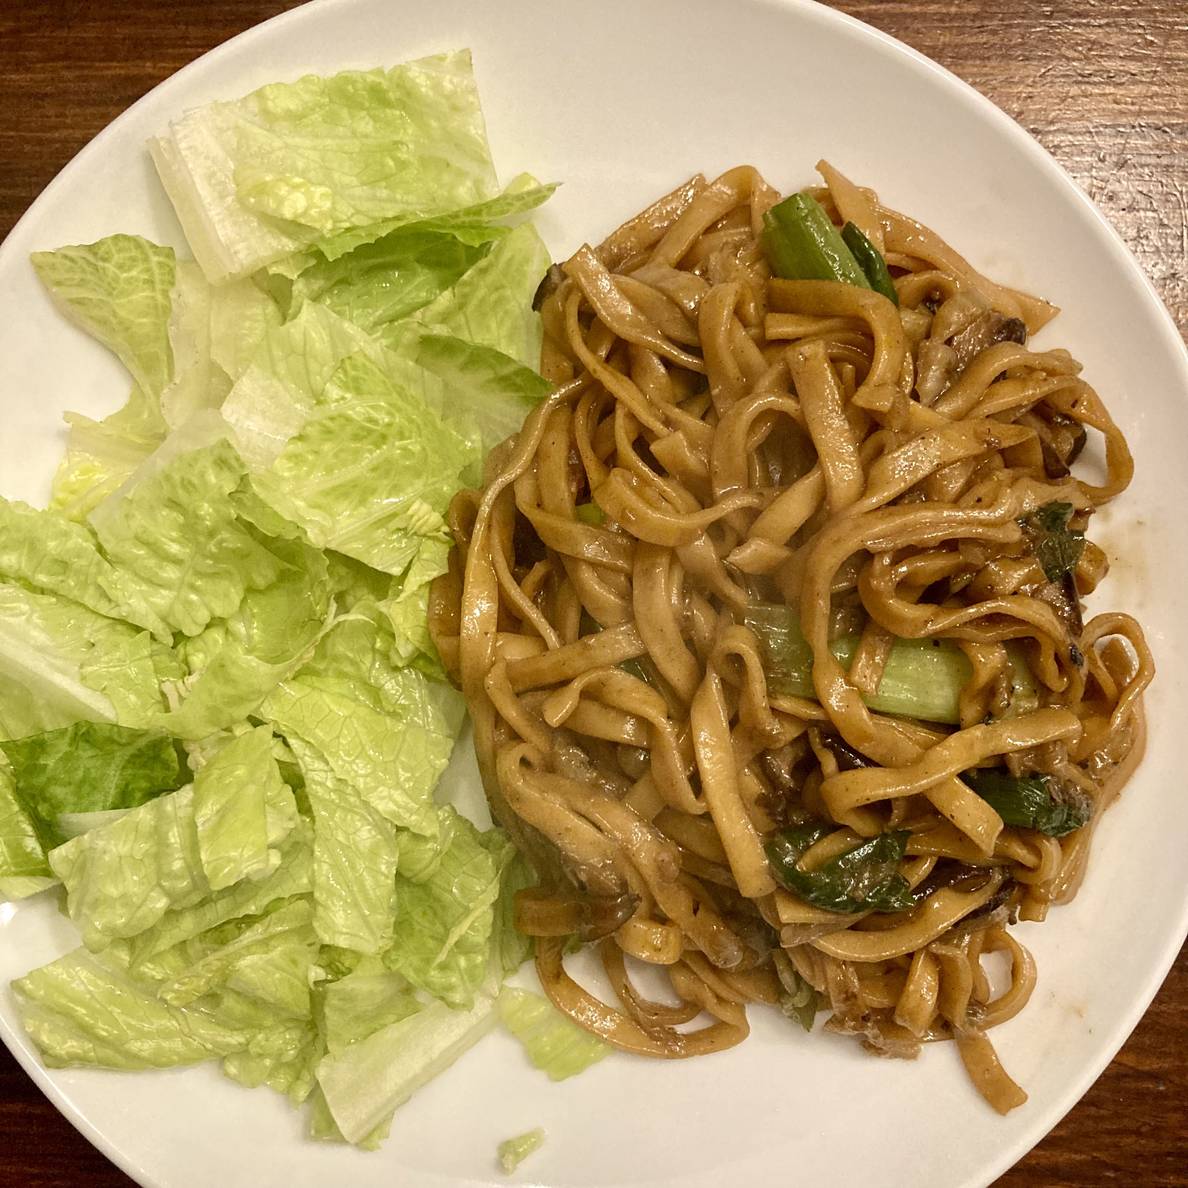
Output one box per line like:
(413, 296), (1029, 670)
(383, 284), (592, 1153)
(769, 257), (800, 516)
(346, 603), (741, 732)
(0, 0), (1188, 1188)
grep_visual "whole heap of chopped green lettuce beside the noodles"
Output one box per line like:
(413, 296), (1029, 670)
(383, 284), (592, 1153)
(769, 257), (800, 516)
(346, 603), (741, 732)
(9, 52), (558, 1148)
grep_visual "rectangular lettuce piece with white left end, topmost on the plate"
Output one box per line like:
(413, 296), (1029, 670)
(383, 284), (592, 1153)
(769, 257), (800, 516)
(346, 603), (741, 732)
(151, 51), (495, 283)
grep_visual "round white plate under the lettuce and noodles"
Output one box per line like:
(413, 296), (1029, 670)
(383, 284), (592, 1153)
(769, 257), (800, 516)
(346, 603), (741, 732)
(0, 0), (1188, 1188)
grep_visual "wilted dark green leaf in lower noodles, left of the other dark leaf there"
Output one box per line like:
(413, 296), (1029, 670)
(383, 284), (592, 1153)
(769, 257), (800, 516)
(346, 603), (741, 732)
(765, 824), (916, 912)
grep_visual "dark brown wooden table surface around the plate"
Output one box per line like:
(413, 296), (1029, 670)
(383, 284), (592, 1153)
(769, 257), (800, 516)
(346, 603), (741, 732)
(0, 0), (1188, 1188)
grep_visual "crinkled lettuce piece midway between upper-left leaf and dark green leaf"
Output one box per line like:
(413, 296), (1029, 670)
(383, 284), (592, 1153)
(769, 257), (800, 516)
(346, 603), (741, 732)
(93, 441), (282, 636)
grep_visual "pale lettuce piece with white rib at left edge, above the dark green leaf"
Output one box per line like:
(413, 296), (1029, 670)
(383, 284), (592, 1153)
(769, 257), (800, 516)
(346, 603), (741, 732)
(0, 582), (171, 739)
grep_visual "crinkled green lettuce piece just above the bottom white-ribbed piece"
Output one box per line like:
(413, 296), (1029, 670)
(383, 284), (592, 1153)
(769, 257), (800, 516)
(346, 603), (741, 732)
(385, 810), (504, 1009)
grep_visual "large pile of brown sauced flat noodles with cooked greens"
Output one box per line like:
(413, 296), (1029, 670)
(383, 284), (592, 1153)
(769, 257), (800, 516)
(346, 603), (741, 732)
(430, 162), (1154, 1112)
